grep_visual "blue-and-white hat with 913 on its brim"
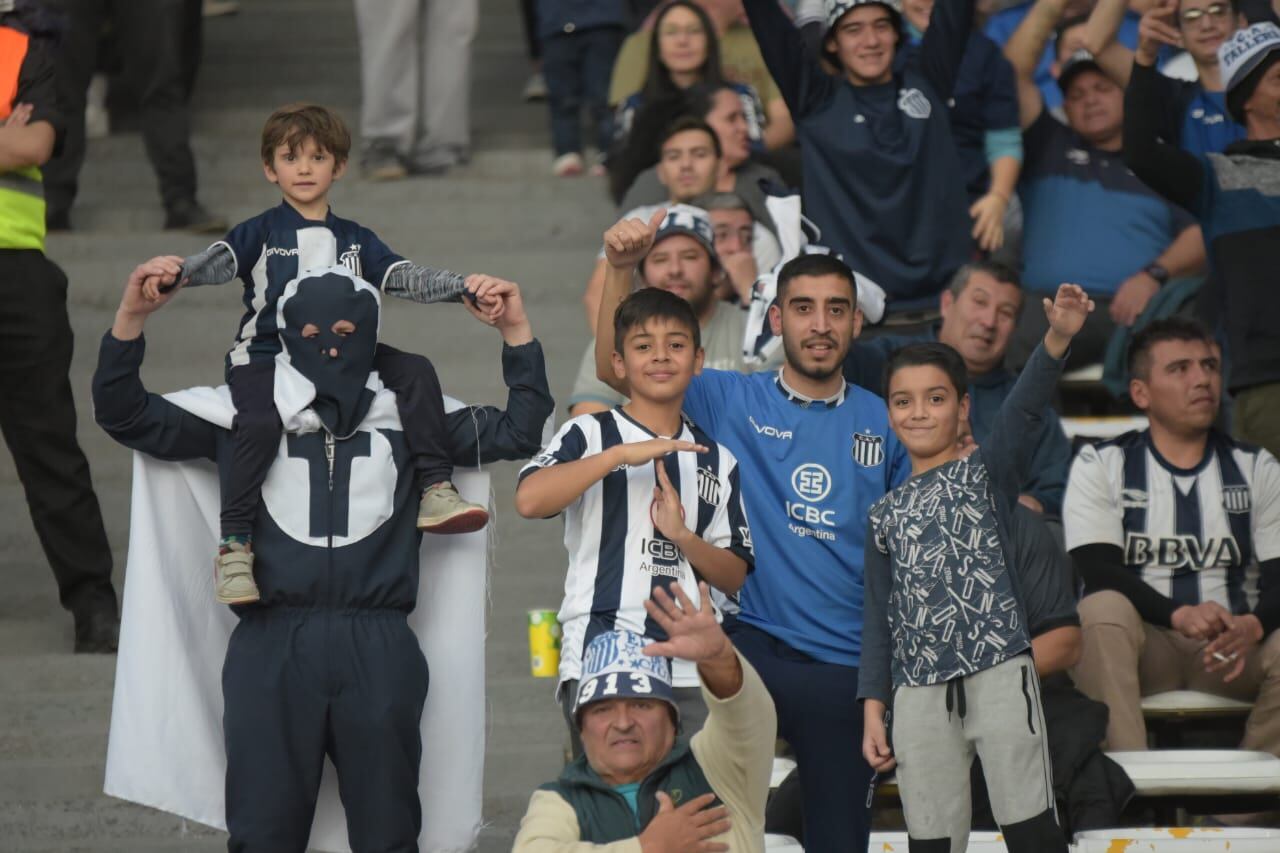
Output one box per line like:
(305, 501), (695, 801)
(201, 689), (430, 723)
(573, 630), (680, 722)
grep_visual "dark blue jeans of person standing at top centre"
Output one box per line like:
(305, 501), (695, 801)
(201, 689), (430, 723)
(543, 27), (626, 156)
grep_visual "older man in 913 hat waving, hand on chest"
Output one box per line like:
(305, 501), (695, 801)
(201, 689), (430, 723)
(512, 583), (777, 853)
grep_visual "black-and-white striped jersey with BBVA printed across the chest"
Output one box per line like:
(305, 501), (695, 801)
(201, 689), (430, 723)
(1062, 430), (1280, 613)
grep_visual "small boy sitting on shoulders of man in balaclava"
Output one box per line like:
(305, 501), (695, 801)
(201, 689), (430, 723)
(136, 104), (497, 605)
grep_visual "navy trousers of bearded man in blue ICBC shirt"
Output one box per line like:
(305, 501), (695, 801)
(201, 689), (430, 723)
(724, 620), (872, 853)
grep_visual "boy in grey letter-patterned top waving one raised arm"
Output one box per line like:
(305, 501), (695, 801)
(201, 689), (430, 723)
(858, 284), (1093, 853)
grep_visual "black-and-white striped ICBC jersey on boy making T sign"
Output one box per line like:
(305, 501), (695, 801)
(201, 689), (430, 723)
(520, 407), (754, 686)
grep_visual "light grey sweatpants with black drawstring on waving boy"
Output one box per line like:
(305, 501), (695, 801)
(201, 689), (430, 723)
(891, 654), (1066, 853)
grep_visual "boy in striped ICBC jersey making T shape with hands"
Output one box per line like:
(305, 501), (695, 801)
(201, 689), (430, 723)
(516, 288), (754, 757)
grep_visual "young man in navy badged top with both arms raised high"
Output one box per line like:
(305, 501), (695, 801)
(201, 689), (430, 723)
(744, 0), (974, 325)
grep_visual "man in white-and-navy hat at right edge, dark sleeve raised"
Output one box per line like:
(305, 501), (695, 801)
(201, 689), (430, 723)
(1124, 22), (1280, 453)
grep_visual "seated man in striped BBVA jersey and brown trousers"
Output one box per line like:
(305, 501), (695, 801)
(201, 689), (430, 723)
(1064, 318), (1280, 754)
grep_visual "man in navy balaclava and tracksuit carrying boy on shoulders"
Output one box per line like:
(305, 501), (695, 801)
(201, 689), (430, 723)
(93, 259), (553, 853)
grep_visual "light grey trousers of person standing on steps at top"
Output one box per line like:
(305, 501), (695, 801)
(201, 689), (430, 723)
(356, 0), (480, 156)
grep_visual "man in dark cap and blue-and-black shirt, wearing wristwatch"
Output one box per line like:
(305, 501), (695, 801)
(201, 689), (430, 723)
(1005, 0), (1204, 368)
